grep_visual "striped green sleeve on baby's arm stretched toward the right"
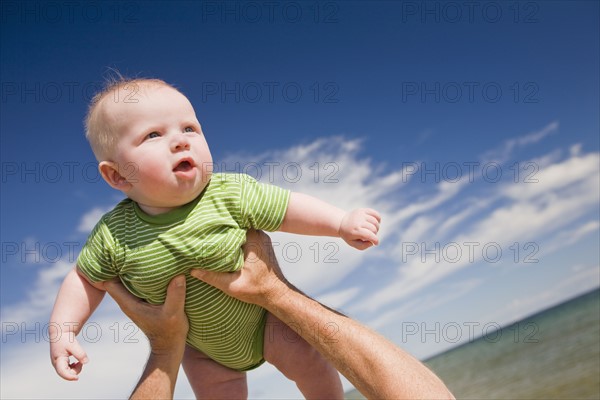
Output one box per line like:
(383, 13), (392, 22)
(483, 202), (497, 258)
(240, 175), (290, 232)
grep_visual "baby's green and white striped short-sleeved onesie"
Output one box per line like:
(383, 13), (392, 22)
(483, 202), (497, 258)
(77, 174), (289, 370)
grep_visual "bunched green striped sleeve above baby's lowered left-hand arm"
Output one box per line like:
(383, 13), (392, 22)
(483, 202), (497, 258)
(77, 217), (117, 282)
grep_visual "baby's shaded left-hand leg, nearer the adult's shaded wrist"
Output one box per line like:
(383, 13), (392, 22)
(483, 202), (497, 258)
(182, 345), (248, 399)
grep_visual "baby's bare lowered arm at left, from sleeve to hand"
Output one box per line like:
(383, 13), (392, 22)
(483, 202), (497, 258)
(48, 267), (106, 381)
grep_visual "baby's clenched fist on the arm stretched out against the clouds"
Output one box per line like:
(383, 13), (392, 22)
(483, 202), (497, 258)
(340, 208), (381, 250)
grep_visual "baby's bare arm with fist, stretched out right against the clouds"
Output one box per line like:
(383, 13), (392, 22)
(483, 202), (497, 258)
(279, 192), (381, 250)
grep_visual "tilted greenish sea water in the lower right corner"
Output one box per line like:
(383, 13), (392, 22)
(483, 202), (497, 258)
(348, 289), (600, 400)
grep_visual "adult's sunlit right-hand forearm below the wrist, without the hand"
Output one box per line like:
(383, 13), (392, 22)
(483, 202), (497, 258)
(262, 282), (453, 399)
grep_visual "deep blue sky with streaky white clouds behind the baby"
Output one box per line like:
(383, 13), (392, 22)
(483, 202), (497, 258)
(0, 1), (600, 398)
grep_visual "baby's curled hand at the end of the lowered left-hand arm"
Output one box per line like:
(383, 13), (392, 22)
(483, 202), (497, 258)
(50, 332), (88, 381)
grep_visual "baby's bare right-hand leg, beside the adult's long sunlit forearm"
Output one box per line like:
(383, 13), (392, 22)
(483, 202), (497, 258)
(264, 313), (344, 400)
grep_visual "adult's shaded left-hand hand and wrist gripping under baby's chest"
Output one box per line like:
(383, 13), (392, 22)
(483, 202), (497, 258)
(104, 276), (189, 399)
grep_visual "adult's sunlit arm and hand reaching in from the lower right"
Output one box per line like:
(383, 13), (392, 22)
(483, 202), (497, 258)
(192, 232), (453, 399)
